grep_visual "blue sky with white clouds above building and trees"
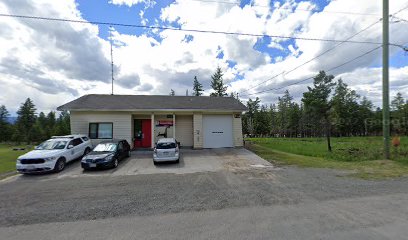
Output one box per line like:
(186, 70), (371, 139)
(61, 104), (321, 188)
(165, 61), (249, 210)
(0, 0), (408, 115)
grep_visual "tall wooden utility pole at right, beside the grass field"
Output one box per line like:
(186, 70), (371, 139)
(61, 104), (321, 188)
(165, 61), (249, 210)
(383, 0), (390, 159)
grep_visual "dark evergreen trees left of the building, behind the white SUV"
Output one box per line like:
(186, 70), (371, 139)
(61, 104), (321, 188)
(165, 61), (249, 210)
(0, 98), (71, 144)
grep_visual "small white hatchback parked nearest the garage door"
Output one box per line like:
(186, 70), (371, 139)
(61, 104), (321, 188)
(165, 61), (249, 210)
(153, 138), (180, 164)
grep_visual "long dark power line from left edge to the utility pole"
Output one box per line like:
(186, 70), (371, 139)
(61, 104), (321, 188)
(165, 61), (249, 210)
(0, 13), (381, 45)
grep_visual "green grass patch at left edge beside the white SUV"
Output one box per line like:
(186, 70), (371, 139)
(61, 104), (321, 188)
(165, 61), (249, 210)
(0, 144), (32, 176)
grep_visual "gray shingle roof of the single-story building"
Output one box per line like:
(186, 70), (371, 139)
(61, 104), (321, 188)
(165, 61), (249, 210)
(57, 94), (247, 112)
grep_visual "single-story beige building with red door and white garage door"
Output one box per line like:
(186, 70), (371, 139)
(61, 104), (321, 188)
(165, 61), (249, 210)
(57, 94), (246, 149)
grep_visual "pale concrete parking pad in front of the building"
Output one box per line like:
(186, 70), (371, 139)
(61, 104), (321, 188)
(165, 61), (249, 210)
(5, 148), (271, 180)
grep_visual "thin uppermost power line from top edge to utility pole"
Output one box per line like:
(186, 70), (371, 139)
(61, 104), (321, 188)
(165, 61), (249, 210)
(186, 0), (380, 17)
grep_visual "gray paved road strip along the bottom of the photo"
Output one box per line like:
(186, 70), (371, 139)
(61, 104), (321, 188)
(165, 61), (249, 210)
(0, 194), (408, 240)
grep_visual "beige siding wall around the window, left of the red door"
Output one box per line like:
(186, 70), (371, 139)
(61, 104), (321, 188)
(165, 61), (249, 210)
(71, 111), (133, 146)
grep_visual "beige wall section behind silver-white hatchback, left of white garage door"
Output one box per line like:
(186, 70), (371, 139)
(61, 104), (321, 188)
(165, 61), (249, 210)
(176, 115), (193, 147)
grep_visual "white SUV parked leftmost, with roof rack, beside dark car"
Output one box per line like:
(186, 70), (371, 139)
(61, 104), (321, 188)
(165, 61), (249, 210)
(16, 135), (92, 173)
